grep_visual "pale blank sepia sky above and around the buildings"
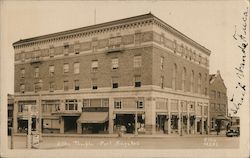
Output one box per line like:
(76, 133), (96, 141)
(0, 1), (249, 117)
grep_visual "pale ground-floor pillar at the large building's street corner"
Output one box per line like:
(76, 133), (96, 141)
(145, 98), (156, 134)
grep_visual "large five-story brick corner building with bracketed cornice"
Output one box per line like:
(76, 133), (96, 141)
(13, 13), (210, 134)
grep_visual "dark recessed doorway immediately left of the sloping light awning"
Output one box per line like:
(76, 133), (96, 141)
(64, 116), (78, 133)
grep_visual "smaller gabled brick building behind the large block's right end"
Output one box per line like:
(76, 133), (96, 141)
(209, 71), (228, 131)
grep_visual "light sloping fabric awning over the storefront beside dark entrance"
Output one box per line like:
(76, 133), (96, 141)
(77, 112), (108, 123)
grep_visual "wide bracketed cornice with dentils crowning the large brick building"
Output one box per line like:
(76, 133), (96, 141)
(13, 13), (211, 55)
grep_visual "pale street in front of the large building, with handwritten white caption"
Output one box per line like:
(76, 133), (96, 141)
(9, 136), (239, 149)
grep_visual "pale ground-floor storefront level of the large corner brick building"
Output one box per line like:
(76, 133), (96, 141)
(13, 87), (210, 135)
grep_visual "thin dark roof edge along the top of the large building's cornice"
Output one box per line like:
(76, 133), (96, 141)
(12, 12), (211, 55)
